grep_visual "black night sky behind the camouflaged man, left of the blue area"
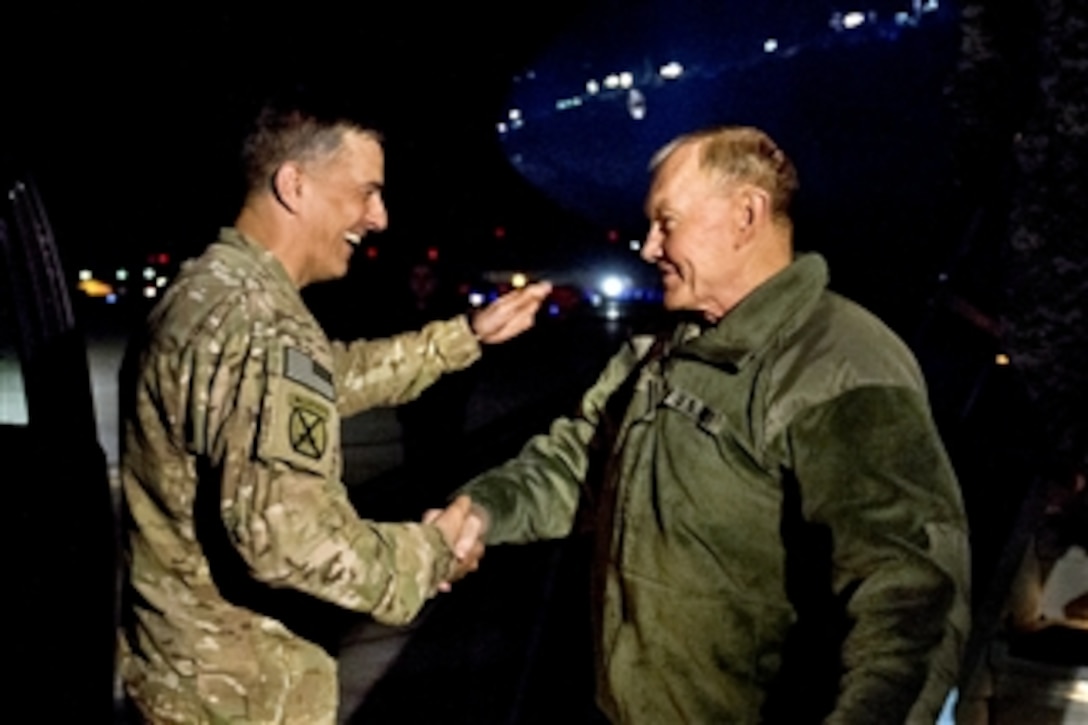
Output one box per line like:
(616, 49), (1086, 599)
(0, 0), (584, 272)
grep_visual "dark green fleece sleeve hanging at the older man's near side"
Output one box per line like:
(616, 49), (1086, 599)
(789, 385), (968, 723)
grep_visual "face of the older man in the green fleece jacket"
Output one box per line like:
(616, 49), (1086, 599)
(642, 143), (747, 322)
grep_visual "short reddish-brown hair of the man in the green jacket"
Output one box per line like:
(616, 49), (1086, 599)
(650, 126), (798, 219)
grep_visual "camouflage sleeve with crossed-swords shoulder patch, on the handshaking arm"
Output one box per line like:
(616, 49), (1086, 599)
(174, 320), (453, 624)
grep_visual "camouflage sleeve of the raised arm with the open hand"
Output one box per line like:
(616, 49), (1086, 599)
(333, 315), (480, 417)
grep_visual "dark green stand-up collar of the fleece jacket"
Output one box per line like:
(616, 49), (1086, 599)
(672, 254), (828, 370)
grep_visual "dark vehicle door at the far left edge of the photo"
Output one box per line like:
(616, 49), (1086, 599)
(0, 180), (116, 723)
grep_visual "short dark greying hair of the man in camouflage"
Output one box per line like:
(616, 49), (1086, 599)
(242, 102), (382, 194)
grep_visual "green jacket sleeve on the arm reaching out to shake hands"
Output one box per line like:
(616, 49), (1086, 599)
(455, 345), (636, 544)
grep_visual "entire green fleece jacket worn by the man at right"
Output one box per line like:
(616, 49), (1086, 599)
(462, 255), (968, 725)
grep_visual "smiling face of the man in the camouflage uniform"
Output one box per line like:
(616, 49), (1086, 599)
(298, 131), (388, 284)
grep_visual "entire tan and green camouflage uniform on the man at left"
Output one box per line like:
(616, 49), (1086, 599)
(120, 229), (480, 725)
